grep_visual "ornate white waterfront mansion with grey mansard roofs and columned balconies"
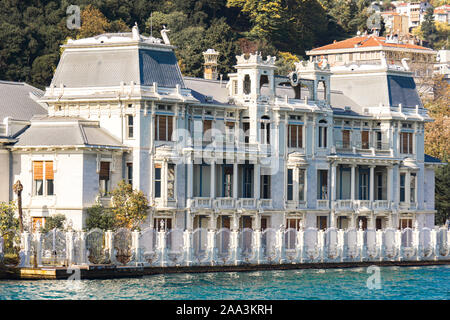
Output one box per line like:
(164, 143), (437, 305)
(0, 27), (438, 230)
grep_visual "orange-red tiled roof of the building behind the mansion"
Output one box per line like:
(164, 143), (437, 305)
(311, 35), (431, 51)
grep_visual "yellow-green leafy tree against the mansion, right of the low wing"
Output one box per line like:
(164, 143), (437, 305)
(111, 180), (149, 229)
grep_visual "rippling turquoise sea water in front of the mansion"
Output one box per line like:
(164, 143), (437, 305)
(0, 266), (450, 300)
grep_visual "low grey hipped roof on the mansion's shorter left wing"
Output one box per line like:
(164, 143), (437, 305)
(14, 117), (125, 148)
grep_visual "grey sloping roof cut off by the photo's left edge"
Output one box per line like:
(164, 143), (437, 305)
(0, 81), (47, 121)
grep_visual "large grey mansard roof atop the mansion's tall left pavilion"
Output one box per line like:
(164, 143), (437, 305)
(51, 47), (185, 88)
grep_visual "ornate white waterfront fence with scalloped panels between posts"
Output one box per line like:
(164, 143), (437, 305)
(0, 227), (450, 267)
